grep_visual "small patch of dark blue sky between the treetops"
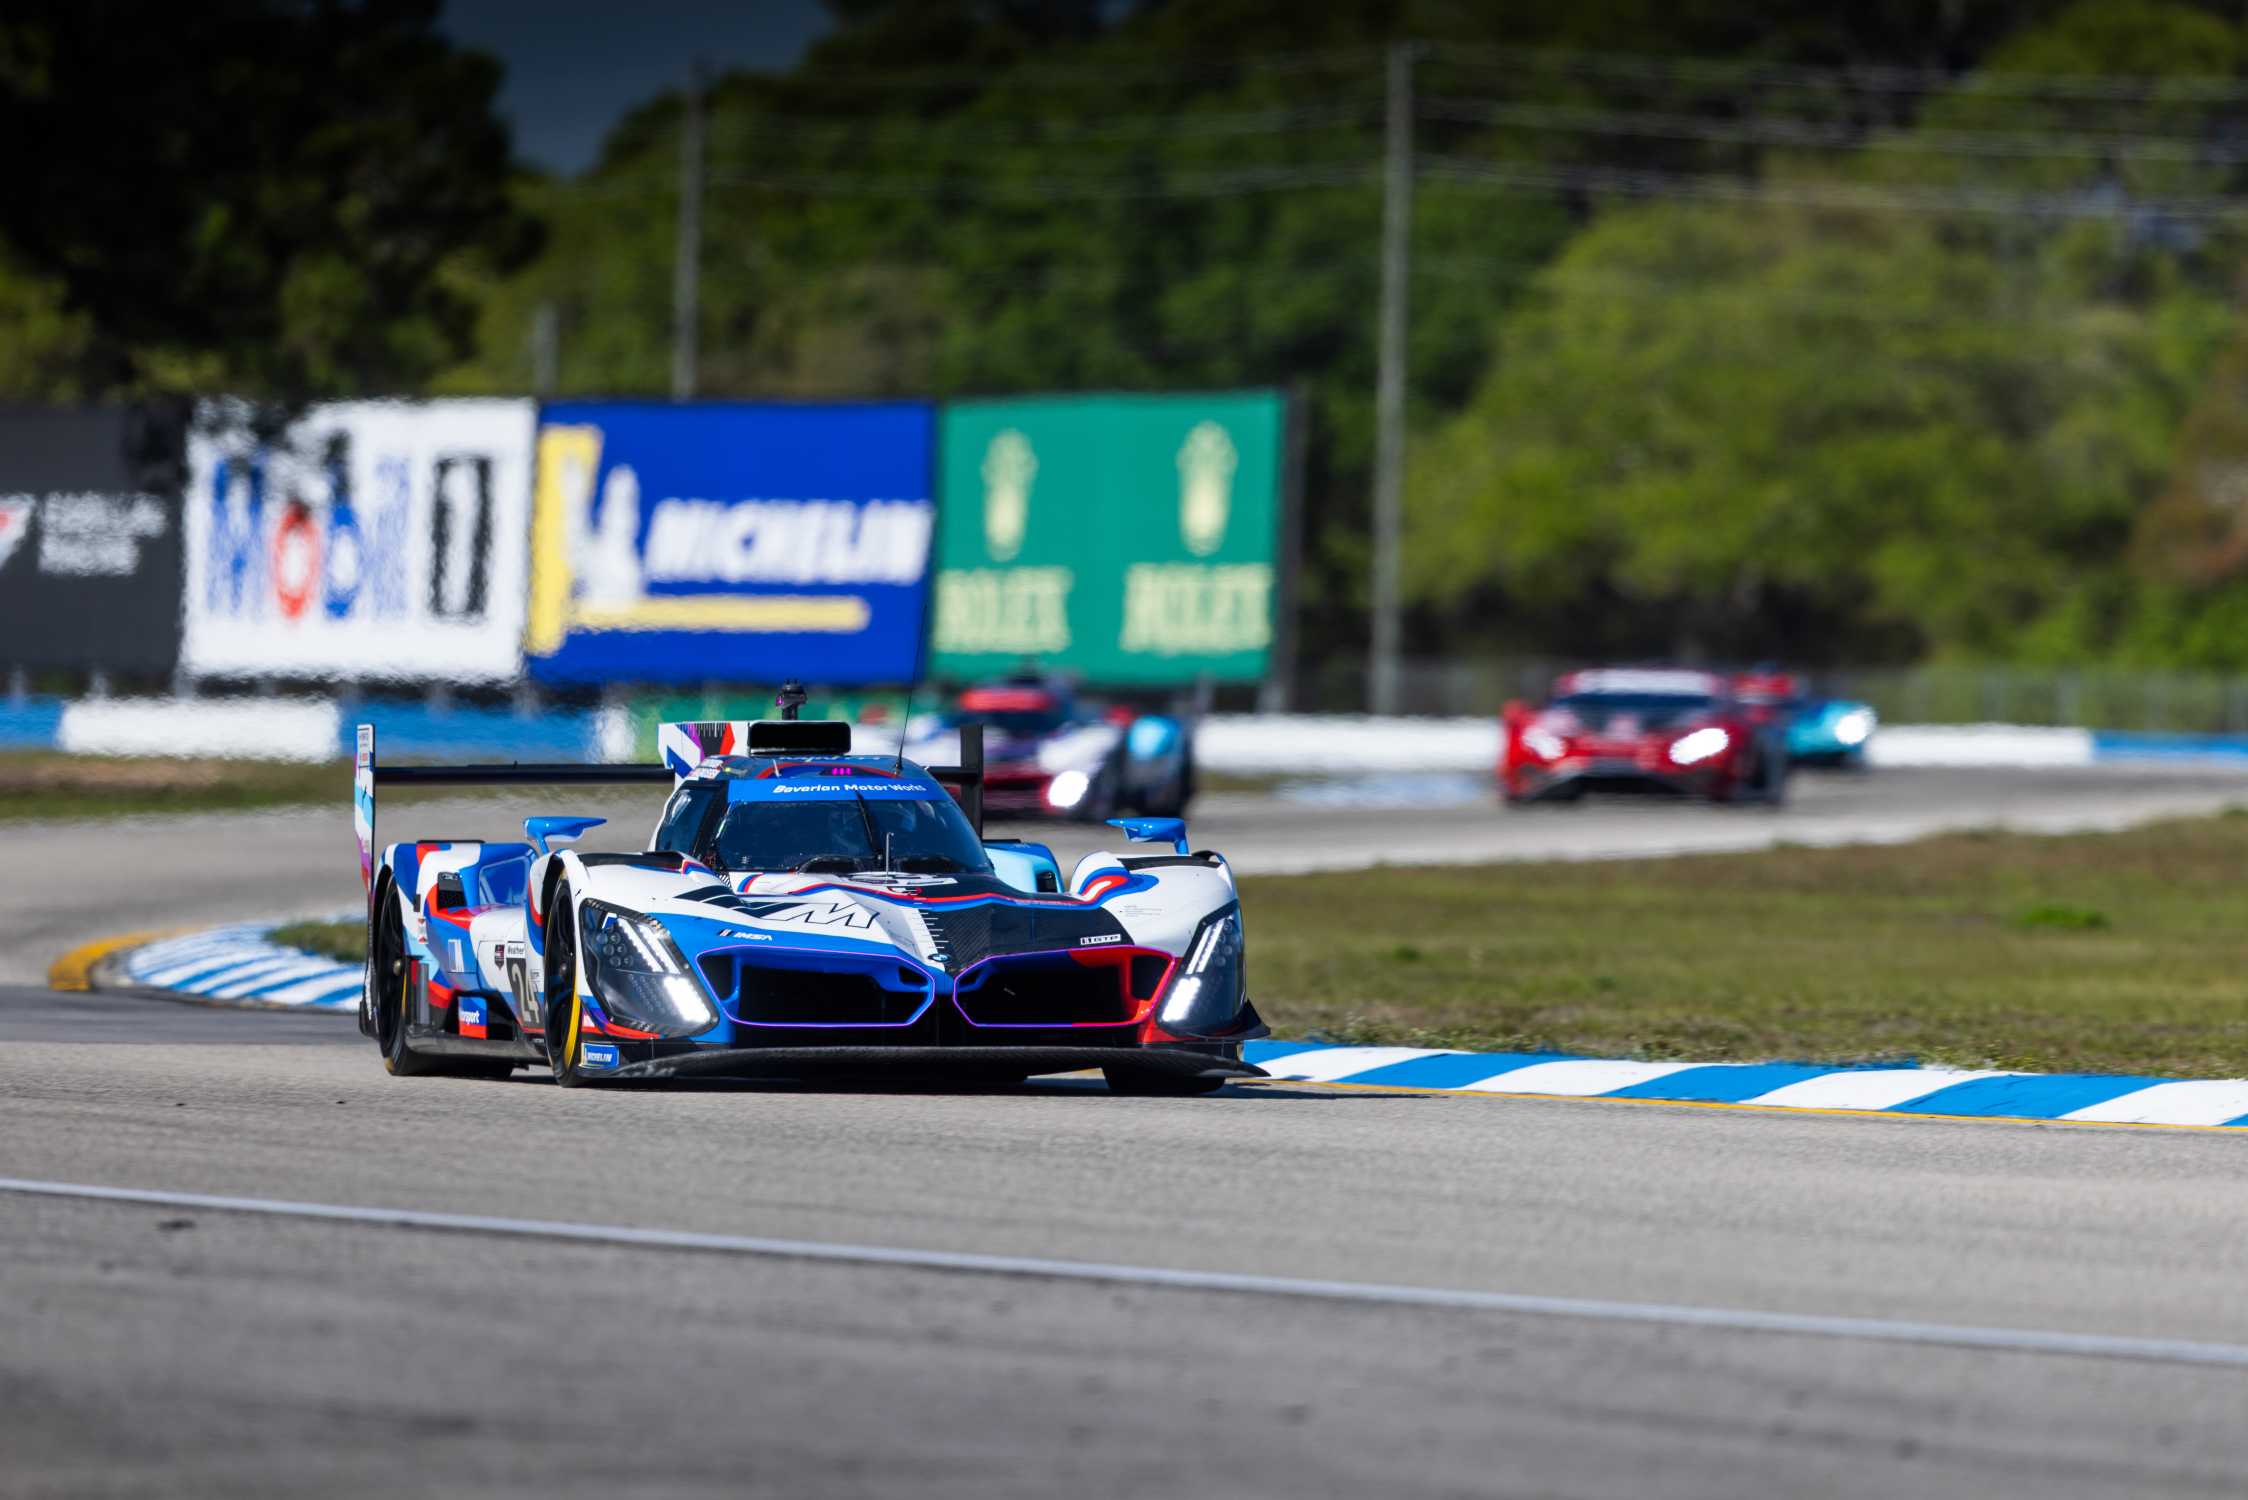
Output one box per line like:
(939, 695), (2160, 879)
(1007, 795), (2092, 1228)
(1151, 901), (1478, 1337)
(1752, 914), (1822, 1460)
(438, 0), (827, 173)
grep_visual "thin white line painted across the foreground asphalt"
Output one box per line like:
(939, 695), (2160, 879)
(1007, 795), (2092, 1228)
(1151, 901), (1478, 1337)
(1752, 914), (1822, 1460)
(0, 1176), (2248, 1370)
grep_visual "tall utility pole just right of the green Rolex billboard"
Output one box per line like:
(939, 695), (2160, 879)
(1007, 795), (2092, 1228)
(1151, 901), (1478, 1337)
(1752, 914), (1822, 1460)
(1367, 43), (1414, 713)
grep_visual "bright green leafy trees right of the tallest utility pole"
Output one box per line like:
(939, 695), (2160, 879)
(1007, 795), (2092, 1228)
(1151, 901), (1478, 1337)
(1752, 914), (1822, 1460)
(1409, 0), (2248, 666)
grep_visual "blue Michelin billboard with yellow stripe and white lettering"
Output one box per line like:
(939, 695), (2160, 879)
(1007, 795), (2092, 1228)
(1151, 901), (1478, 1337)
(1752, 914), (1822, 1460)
(526, 400), (935, 686)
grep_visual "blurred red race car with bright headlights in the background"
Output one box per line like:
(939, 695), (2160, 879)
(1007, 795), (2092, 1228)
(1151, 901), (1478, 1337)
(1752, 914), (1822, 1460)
(1499, 668), (1787, 803)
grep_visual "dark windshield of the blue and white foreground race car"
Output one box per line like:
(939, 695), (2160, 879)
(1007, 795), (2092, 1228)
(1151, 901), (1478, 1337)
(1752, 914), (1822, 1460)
(710, 796), (991, 875)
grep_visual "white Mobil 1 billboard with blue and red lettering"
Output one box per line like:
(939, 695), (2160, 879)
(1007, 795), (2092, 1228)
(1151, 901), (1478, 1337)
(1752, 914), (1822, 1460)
(182, 400), (537, 684)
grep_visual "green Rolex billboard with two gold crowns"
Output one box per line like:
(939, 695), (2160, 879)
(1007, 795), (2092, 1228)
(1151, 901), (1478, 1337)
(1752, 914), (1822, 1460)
(933, 391), (1288, 686)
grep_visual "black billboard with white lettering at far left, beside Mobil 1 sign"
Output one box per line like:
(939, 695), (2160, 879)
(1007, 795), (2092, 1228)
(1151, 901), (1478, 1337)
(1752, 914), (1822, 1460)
(0, 407), (187, 677)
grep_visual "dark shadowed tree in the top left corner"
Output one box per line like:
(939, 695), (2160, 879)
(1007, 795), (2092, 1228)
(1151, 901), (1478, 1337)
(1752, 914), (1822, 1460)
(0, 0), (535, 398)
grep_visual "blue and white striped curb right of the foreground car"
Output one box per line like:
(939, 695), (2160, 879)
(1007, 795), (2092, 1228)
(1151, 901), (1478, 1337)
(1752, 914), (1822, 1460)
(1243, 1041), (2248, 1127)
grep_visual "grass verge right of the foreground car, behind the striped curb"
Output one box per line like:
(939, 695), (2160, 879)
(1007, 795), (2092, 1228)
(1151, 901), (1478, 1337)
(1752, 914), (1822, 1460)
(255, 816), (2248, 1077)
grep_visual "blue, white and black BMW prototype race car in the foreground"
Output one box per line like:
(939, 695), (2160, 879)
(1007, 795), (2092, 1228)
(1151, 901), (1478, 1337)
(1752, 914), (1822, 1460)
(353, 720), (1266, 1093)
